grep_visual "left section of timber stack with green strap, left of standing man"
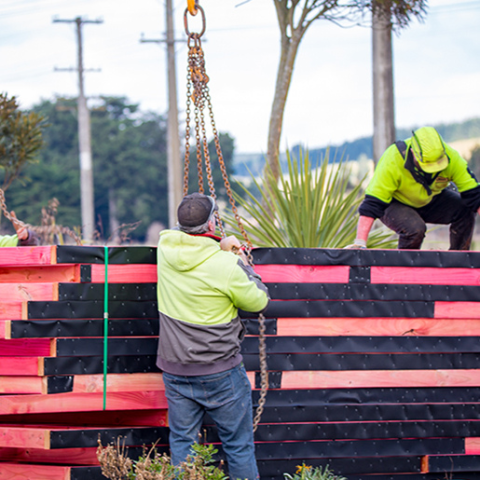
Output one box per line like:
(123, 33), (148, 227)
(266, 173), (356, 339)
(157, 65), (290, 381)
(0, 246), (168, 480)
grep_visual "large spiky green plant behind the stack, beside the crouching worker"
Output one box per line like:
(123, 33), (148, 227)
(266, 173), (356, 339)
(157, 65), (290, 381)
(225, 148), (396, 248)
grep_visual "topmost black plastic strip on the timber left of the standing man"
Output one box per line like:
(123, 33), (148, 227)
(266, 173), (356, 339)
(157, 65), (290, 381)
(57, 245), (157, 265)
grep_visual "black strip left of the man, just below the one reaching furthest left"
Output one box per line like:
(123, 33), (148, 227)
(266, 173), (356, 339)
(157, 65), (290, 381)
(56, 338), (158, 357)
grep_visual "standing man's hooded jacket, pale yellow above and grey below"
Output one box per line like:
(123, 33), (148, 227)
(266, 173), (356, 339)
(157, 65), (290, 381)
(157, 230), (269, 375)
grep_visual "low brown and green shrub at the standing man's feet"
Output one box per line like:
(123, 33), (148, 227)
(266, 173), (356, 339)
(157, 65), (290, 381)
(97, 438), (228, 480)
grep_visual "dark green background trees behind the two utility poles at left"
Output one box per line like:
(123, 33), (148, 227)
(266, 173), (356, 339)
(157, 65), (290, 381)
(3, 97), (234, 242)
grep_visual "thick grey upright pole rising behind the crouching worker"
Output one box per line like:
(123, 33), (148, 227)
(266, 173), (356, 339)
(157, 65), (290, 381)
(372, 9), (395, 164)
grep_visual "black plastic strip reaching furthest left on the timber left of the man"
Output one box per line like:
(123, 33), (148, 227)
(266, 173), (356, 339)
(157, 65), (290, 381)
(11, 318), (159, 338)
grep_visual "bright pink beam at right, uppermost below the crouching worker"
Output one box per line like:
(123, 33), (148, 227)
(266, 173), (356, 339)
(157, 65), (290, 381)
(370, 267), (480, 285)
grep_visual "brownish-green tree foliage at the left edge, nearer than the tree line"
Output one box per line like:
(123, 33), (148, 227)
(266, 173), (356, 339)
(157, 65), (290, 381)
(0, 93), (46, 190)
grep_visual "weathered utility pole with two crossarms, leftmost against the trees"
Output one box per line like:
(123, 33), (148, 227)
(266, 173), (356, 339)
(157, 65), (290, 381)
(53, 17), (103, 242)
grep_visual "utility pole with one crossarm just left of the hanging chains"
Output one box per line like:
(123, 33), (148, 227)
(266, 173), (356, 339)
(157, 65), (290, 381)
(140, 0), (183, 228)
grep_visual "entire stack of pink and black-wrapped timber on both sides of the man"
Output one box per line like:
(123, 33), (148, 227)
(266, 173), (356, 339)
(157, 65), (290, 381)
(0, 247), (480, 480)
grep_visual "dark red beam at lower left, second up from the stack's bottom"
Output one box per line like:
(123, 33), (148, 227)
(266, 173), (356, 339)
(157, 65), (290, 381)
(0, 447), (99, 465)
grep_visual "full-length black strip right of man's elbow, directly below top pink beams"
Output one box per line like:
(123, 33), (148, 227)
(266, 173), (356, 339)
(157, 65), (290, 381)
(266, 283), (480, 302)
